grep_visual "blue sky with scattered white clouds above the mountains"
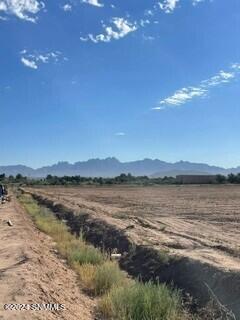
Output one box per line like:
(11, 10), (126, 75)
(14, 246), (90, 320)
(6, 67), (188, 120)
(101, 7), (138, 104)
(0, 0), (240, 167)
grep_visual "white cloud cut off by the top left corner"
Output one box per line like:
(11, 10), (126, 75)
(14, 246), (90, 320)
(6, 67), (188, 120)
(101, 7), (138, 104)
(0, 0), (45, 22)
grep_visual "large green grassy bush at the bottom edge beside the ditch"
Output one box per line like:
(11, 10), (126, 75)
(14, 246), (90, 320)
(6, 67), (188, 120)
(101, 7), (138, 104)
(99, 282), (184, 320)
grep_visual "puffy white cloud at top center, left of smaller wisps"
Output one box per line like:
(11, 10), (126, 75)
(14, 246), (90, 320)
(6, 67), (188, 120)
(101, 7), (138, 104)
(80, 17), (138, 43)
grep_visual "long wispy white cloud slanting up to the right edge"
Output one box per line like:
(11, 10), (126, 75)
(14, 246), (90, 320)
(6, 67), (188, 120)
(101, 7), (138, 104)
(152, 63), (240, 110)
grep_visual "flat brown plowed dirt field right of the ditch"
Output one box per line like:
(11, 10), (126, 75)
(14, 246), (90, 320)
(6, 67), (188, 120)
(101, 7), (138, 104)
(29, 185), (240, 271)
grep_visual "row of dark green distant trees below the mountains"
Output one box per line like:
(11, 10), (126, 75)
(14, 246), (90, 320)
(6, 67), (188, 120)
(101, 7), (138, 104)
(0, 173), (240, 185)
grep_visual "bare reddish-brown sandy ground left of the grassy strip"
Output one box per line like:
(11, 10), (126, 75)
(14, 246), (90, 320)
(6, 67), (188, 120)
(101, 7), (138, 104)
(0, 199), (94, 320)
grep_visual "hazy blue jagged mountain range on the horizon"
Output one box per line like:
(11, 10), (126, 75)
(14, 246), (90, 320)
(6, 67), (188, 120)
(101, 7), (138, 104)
(0, 157), (240, 178)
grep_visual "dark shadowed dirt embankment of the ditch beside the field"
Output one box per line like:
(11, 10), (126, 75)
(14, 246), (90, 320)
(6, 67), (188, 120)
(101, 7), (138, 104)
(28, 191), (240, 319)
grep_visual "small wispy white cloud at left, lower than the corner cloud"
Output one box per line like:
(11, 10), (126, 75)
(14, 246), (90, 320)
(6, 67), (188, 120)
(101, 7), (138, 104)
(20, 49), (67, 70)
